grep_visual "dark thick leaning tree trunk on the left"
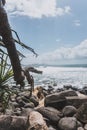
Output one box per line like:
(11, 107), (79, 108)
(0, 5), (24, 84)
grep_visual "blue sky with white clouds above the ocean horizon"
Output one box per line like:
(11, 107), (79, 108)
(5, 0), (87, 65)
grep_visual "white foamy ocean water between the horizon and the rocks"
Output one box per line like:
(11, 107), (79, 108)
(32, 64), (87, 89)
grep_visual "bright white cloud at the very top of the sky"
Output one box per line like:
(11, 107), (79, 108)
(6, 0), (71, 18)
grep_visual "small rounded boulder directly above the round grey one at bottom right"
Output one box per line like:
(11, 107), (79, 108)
(62, 106), (77, 117)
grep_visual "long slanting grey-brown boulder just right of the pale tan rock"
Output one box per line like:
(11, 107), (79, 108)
(37, 107), (63, 123)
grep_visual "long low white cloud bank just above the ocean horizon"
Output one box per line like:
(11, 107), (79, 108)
(24, 39), (87, 64)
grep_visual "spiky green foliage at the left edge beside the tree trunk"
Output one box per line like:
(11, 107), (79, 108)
(0, 50), (13, 112)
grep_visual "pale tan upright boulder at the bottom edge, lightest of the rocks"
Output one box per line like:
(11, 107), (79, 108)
(28, 111), (48, 130)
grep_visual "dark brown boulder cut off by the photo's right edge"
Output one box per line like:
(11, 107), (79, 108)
(76, 102), (87, 123)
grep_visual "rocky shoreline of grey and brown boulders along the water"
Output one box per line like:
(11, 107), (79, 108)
(0, 85), (87, 130)
